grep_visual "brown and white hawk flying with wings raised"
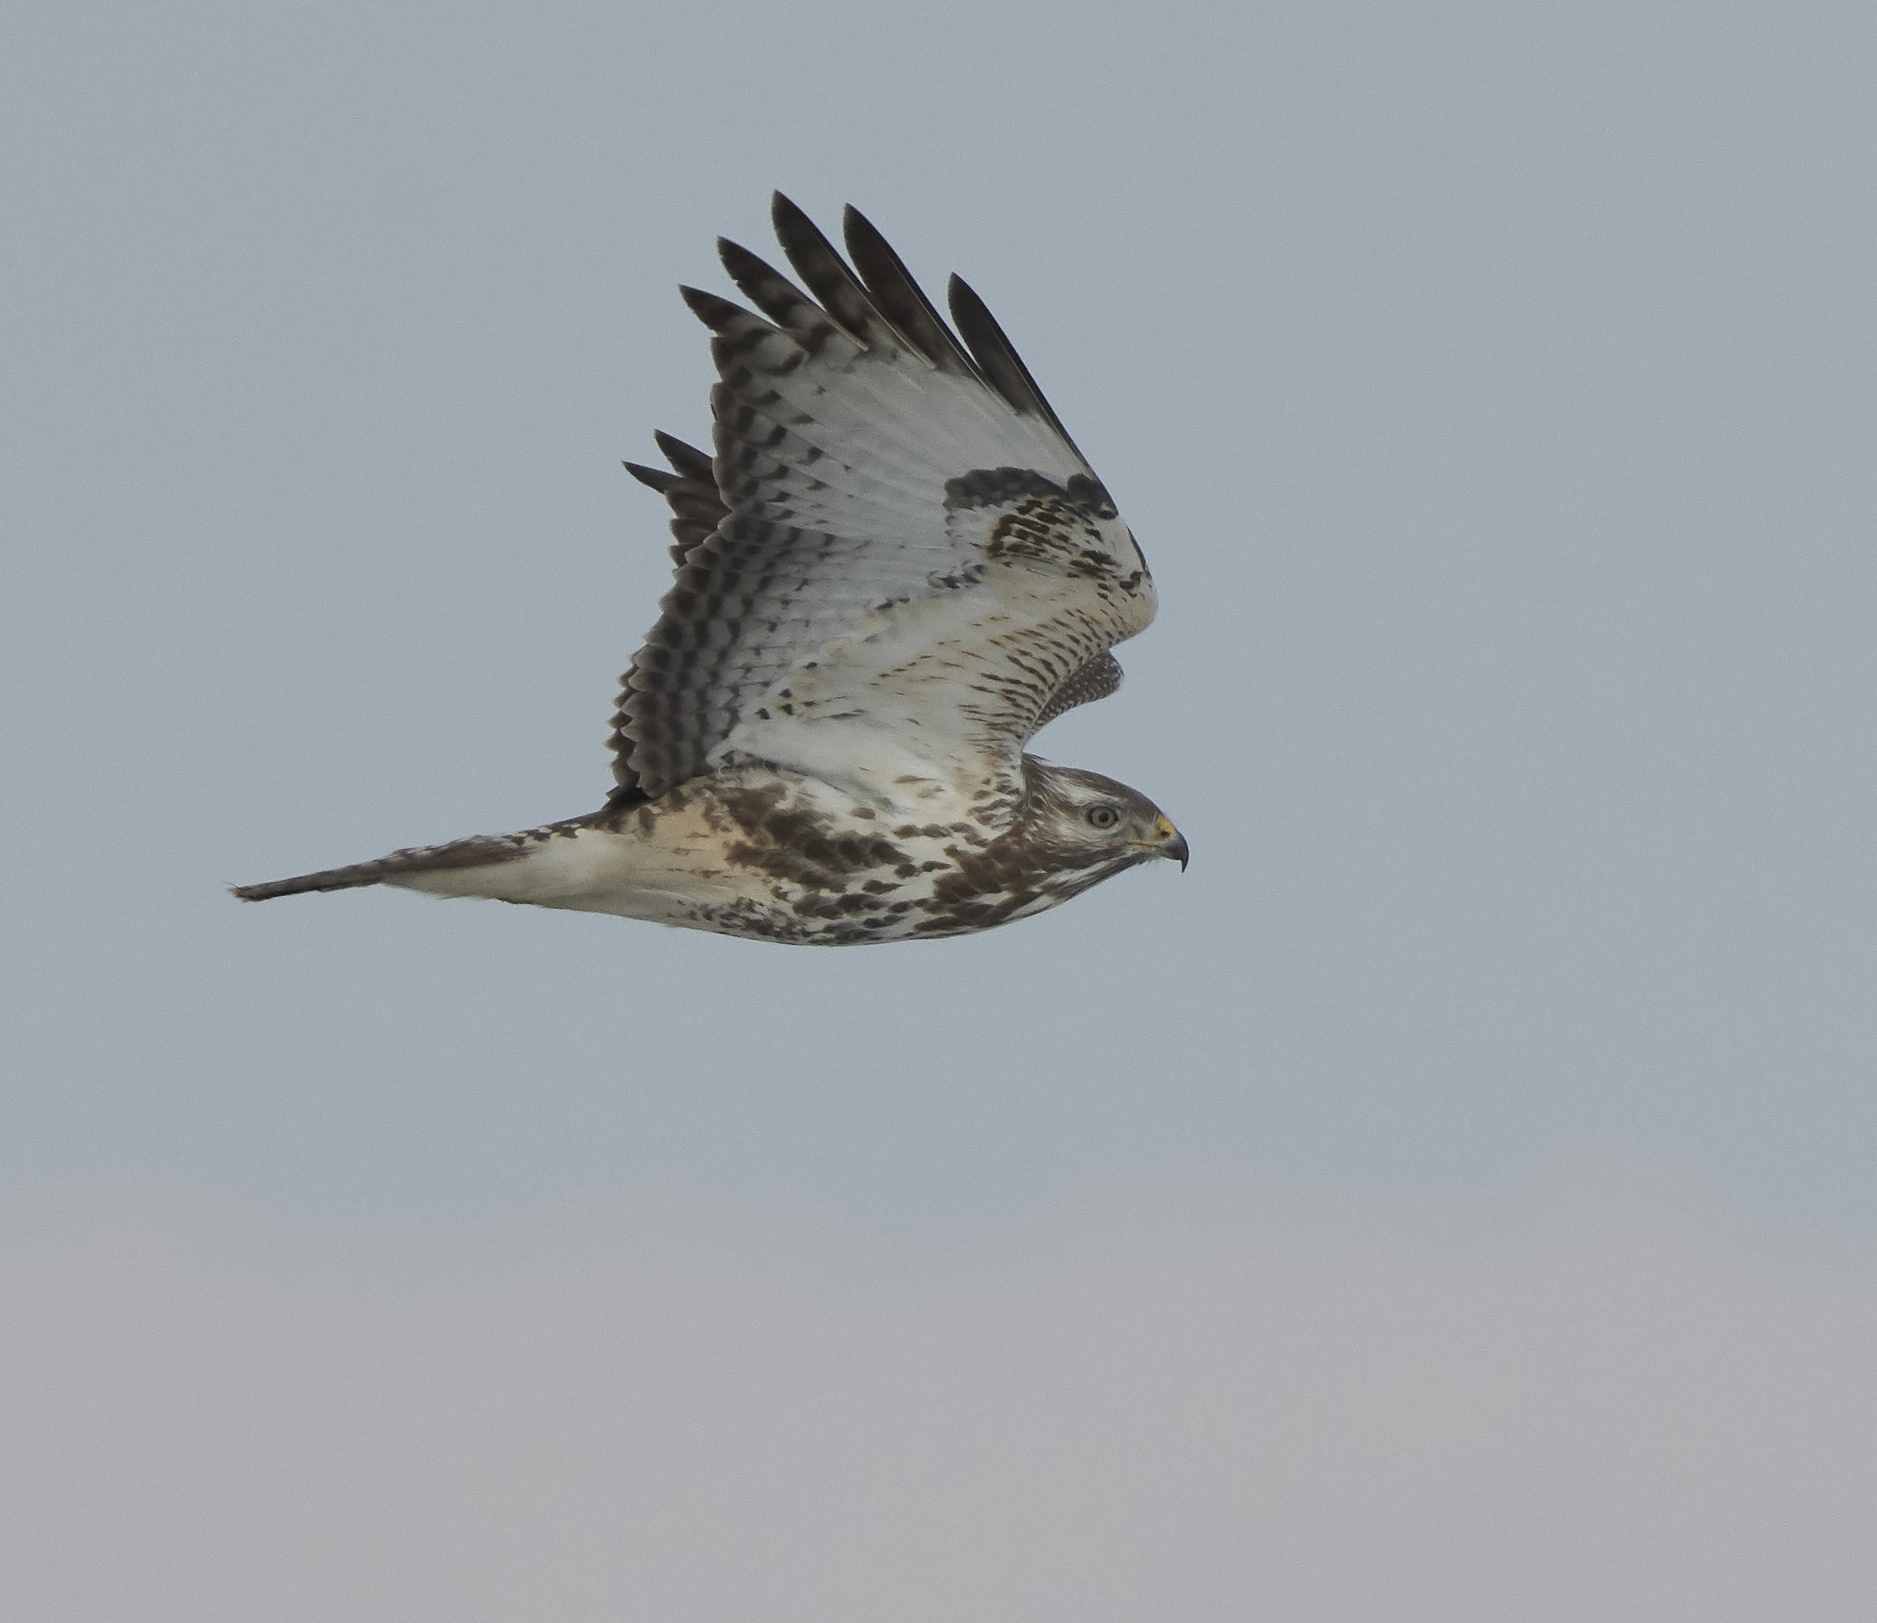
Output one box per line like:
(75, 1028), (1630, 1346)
(235, 195), (1186, 946)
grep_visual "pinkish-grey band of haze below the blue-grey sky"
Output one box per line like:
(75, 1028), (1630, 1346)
(11, 1167), (1877, 1623)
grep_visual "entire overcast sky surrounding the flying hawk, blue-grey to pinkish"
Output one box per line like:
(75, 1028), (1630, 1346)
(0, 0), (1877, 1623)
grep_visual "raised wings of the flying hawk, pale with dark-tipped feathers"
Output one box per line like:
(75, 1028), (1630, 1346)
(614, 195), (1154, 799)
